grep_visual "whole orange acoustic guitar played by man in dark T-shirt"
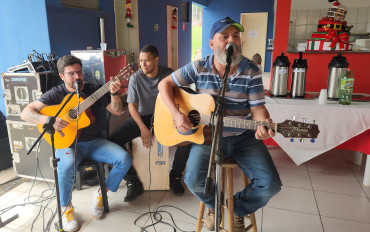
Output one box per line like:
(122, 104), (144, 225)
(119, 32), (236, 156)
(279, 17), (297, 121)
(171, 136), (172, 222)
(37, 64), (134, 149)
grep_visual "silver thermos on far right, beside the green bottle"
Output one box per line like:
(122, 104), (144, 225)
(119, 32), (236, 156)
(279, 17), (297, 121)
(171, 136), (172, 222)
(327, 53), (348, 100)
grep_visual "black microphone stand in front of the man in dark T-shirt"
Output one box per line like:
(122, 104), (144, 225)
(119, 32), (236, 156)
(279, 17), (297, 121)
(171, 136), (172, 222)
(27, 92), (79, 231)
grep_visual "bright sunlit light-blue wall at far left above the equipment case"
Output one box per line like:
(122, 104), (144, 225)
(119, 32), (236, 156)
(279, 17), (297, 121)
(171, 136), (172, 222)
(0, 0), (50, 116)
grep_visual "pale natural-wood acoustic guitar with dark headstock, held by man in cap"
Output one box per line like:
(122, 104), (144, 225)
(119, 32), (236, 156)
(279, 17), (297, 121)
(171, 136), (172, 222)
(154, 88), (320, 146)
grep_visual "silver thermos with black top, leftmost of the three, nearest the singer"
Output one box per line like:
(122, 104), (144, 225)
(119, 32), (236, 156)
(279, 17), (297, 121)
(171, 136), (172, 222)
(271, 52), (290, 97)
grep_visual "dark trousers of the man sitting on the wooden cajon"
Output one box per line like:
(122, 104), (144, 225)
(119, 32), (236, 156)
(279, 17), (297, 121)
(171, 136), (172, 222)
(109, 114), (191, 181)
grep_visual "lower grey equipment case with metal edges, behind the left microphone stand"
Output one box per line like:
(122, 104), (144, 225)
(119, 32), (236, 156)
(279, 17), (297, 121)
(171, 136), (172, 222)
(6, 120), (54, 182)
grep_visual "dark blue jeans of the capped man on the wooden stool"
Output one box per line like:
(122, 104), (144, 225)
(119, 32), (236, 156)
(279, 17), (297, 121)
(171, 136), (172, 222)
(184, 131), (282, 216)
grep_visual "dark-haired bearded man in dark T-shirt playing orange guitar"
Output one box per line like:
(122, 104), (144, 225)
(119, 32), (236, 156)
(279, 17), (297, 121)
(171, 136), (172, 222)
(21, 55), (132, 231)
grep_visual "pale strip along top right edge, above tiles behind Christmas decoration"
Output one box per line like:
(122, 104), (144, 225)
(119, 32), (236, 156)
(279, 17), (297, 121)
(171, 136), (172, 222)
(291, 0), (370, 10)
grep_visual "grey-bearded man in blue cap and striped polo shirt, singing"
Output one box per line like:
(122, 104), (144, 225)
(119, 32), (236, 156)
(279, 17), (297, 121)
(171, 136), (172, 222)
(159, 17), (282, 232)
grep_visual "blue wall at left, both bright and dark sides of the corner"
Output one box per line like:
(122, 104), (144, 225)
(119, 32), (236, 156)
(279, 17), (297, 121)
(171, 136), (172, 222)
(0, 0), (116, 115)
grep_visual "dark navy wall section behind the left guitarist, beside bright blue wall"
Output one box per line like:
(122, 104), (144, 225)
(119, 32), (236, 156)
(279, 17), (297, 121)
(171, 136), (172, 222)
(47, 6), (116, 56)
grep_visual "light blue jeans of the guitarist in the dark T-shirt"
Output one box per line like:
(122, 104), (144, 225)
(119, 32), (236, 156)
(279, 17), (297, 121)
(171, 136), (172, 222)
(55, 139), (132, 207)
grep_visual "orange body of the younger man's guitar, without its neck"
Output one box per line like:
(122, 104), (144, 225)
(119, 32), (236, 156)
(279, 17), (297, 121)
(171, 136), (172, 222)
(37, 95), (93, 149)
